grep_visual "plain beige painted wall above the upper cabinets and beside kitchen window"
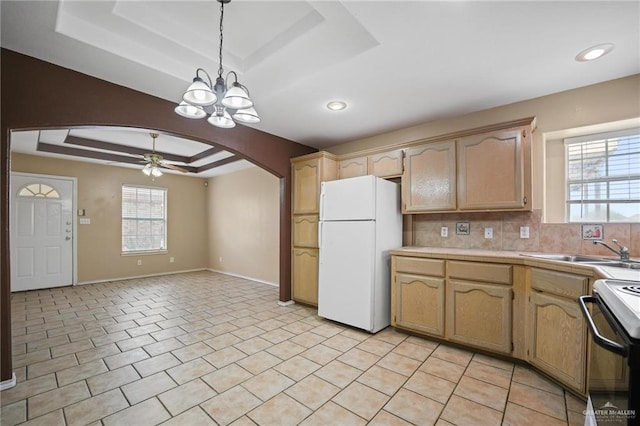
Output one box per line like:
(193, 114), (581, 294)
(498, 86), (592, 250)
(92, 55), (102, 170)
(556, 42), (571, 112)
(326, 74), (640, 213)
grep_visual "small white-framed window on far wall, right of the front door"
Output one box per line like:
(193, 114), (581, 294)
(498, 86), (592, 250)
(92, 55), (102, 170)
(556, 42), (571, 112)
(122, 185), (167, 253)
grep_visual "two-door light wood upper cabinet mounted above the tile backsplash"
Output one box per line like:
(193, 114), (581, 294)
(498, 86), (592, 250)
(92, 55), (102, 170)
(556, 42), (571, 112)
(402, 118), (534, 213)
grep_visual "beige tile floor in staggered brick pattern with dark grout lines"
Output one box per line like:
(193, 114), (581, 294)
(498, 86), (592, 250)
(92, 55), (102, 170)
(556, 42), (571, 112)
(0, 272), (584, 426)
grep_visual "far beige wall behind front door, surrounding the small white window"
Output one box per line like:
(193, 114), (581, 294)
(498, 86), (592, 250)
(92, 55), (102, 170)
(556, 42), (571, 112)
(11, 153), (208, 283)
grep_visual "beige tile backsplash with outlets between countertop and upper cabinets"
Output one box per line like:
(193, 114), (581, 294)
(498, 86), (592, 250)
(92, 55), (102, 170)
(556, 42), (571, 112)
(412, 210), (640, 257)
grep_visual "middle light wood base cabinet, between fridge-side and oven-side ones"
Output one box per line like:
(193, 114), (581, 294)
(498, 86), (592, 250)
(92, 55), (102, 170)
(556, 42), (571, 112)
(446, 261), (513, 354)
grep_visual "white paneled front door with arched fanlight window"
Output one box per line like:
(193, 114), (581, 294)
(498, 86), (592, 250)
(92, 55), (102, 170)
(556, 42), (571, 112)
(9, 173), (75, 291)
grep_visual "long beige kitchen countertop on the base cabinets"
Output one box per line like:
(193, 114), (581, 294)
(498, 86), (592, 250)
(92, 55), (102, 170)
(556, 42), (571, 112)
(391, 246), (640, 281)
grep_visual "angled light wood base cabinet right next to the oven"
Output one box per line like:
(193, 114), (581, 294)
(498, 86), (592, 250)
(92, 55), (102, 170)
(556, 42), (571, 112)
(527, 268), (589, 394)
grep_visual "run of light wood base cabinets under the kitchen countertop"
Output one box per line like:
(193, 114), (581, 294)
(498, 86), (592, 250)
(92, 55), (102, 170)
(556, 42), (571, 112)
(391, 255), (596, 395)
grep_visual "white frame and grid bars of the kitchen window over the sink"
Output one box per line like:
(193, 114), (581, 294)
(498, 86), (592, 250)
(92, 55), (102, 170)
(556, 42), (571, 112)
(563, 127), (640, 223)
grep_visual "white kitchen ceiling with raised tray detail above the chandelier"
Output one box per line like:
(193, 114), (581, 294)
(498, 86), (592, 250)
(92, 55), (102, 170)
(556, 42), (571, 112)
(0, 0), (640, 148)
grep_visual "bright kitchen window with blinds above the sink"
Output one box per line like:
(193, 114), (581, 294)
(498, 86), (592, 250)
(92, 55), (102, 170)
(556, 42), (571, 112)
(565, 128), (640, 222)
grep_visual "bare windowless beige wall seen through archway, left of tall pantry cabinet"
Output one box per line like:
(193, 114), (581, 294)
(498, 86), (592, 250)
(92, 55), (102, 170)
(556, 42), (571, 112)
(207, 167), (280, 285)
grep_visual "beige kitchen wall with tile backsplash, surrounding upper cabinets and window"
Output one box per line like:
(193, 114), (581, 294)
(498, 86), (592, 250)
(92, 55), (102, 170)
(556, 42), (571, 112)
(326, 74), (640, 257)
